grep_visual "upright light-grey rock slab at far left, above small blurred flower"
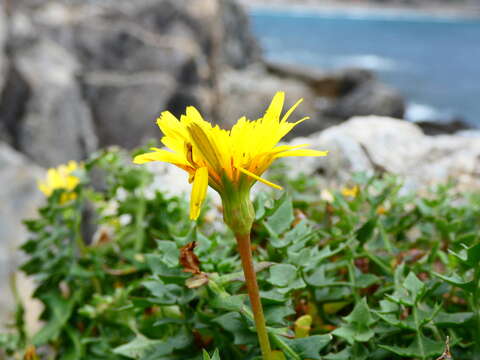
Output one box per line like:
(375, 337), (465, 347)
(11, 39), (97, 166)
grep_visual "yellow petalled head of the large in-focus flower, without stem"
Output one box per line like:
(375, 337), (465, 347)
(134, 92), (327, 220)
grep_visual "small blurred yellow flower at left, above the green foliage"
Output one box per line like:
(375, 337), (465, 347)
(38, 161), (80, 202)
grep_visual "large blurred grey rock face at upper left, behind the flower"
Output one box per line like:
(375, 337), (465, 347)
(0, 0), (259, 150)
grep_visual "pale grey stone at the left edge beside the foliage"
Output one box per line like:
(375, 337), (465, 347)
(0, 142), (44, 330)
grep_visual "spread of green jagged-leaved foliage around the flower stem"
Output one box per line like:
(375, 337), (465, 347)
(0, 150), (480, 360)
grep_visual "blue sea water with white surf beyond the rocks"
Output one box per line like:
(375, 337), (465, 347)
(251, 9), (480, 127)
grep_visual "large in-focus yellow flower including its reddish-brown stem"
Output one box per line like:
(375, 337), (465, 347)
(134, 92), (327, 360)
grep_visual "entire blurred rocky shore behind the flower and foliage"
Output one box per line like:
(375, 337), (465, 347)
(0, 0), (480, 327)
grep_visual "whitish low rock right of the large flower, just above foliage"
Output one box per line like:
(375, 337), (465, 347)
(286, 116), (480, 188)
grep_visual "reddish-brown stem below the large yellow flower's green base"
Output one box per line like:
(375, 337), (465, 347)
(235, 233), (272, 360)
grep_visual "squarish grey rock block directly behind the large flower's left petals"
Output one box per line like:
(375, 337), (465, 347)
(84, 72), (210, 148)
